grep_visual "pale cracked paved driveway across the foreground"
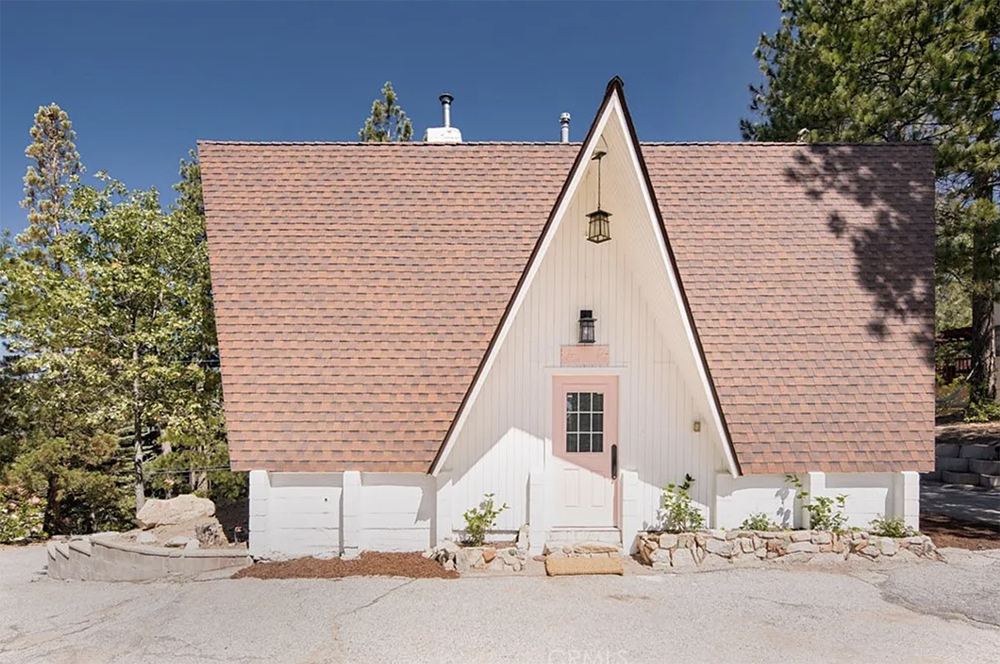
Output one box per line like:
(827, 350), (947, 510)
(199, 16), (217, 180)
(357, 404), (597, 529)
(0, 547), (1000, 664)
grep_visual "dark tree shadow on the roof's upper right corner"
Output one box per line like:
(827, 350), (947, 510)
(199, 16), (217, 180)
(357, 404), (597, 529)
(784, 144), (934, 366)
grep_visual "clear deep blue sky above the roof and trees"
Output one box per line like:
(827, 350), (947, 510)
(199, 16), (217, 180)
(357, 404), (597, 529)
(0, 0), (779, 236)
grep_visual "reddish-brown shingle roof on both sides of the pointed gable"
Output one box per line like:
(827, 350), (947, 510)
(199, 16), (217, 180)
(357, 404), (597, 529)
(199, 142), (934, 473)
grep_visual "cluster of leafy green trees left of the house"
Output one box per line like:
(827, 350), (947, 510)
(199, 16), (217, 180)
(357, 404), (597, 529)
(0, 107), (244, 533)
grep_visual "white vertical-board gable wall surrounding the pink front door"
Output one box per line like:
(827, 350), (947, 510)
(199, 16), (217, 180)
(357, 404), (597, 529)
(443, 106), (727, 531)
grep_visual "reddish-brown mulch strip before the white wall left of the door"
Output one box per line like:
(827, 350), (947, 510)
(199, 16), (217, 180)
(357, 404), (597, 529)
(233, 551), (458, 579)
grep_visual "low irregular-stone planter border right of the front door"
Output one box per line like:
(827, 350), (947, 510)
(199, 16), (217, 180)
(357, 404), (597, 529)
(637, 530), (940, 569)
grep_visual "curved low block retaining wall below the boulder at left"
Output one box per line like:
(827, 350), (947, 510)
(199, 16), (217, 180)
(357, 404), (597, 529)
(47, 535), (250, 581)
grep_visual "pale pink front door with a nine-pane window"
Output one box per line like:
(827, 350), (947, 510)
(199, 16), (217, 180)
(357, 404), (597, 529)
(552, 376), (618, 527)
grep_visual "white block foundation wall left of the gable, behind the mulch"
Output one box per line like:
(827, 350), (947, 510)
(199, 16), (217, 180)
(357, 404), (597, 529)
(250, 470), (435, 559)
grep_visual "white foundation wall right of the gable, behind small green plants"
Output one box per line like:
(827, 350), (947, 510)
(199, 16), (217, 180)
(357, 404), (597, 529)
(713, 472), (920, 528)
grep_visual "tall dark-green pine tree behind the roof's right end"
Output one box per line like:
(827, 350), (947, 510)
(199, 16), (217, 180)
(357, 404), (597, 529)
(741, 0), (1000, 400)
